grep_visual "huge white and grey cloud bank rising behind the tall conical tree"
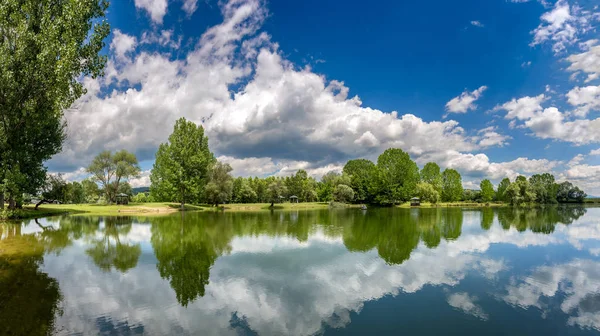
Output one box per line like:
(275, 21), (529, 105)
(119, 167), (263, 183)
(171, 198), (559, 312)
(49, 0), (520, 186)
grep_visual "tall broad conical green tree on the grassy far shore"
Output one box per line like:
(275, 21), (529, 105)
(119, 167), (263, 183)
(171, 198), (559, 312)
(150, 118), (215, 208)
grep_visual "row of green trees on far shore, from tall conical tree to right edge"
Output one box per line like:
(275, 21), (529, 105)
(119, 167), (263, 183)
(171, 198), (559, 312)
(138, 118), (586, 206)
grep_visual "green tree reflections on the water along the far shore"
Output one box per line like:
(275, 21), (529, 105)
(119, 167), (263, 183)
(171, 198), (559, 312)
(0, 206), (586, 316)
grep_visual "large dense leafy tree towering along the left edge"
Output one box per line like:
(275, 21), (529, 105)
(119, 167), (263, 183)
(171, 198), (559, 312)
(0, 0), (110, 208)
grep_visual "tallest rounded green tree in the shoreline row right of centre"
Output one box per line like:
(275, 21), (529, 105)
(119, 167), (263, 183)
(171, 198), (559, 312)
(375, 148), (419, 204)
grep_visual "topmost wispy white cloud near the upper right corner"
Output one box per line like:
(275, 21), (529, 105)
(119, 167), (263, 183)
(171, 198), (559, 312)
(530, 0), (594, 53)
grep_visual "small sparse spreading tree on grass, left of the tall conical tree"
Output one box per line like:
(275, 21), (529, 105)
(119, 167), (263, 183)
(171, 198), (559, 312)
(86, 149), (140, 203)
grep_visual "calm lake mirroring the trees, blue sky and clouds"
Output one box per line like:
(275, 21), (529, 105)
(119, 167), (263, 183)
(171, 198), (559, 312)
(0, 207), (600, 335)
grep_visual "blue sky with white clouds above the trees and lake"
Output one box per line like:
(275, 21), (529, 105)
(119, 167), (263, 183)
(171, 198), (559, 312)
(48, 0), (600, 194)
